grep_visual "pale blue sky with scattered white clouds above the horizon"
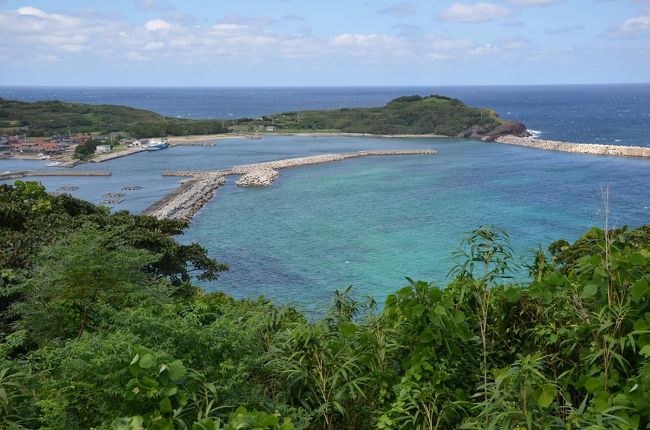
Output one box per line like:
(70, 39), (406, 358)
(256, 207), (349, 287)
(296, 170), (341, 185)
(0, 0), (650, 86)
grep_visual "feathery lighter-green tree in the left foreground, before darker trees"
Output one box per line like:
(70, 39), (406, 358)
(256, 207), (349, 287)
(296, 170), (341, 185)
(16, 224), (156, 342)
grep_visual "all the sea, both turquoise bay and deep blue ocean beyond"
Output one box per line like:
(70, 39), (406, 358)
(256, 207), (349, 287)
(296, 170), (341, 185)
(0, 84), (650, 312)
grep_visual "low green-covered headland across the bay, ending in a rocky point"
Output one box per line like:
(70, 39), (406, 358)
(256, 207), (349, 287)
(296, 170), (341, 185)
(0, 96), (527, 138)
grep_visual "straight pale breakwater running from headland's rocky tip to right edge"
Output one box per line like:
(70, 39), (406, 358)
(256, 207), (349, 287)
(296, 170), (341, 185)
(495, 135), (650, 157)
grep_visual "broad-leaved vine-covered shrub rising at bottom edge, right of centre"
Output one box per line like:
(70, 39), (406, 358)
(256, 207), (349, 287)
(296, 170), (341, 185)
(377, 279), (470, 429)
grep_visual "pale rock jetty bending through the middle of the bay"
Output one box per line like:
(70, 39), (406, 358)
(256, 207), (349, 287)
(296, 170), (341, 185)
(143, 149), (436, 220)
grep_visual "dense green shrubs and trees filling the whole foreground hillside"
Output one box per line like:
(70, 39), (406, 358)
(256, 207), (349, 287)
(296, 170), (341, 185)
(0, 182), (650, 430)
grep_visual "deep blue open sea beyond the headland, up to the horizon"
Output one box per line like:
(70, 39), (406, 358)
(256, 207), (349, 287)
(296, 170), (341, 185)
(0, 84), (650, 146)
